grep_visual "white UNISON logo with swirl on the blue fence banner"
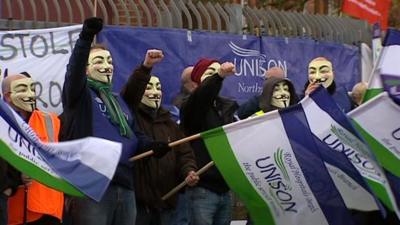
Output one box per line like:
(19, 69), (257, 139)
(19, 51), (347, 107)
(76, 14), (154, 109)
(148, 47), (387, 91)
(228, 42), (287, 77)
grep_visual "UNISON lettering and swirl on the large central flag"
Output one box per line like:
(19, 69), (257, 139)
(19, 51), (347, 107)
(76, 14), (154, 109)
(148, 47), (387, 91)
(256, 148), (297, 213)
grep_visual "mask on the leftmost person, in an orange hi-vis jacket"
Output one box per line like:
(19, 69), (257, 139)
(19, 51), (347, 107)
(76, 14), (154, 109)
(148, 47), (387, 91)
(10, 78), (36, 112)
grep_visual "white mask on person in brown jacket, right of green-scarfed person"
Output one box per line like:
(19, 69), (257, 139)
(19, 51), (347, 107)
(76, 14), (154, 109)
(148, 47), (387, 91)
(142, 76), (162, 109)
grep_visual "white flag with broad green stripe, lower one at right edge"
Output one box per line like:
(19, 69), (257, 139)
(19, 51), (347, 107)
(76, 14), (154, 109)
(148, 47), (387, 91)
(348, 92), (400, 214)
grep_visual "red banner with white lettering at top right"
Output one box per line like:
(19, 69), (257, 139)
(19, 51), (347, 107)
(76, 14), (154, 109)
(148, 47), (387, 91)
(342, 0), (391, 30)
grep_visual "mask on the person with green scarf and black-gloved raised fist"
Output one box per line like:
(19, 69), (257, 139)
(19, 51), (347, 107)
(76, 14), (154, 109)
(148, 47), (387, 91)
(87, 49), (114, 83)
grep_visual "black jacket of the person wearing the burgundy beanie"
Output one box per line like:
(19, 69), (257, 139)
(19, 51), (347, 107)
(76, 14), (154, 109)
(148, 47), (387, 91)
(181, 75), (238, 193)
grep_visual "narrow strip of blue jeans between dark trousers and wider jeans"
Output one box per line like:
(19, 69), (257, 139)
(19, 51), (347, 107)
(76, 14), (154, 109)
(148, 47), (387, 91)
(171, 191), (191, 225)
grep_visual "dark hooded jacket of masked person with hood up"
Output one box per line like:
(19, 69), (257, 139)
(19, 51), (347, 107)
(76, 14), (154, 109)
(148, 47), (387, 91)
(237, 77), (298, 119)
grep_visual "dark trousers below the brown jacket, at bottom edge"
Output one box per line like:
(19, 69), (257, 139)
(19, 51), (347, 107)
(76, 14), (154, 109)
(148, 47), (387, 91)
(136, 204), (175, 225)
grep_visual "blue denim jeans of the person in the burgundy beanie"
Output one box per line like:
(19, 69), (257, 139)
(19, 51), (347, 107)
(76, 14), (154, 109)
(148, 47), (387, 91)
(189, 187), (232, 225)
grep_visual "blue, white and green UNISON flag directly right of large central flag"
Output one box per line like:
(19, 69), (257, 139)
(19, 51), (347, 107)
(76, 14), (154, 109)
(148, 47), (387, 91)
(301, 88), (398, 216)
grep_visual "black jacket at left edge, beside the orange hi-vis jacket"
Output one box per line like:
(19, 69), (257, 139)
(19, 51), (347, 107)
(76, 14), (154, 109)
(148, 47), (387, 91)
(0, 158), (22, 195)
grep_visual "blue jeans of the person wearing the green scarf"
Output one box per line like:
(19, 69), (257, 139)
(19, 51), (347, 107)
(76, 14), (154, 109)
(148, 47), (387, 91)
(69, 185), (136, 225)
